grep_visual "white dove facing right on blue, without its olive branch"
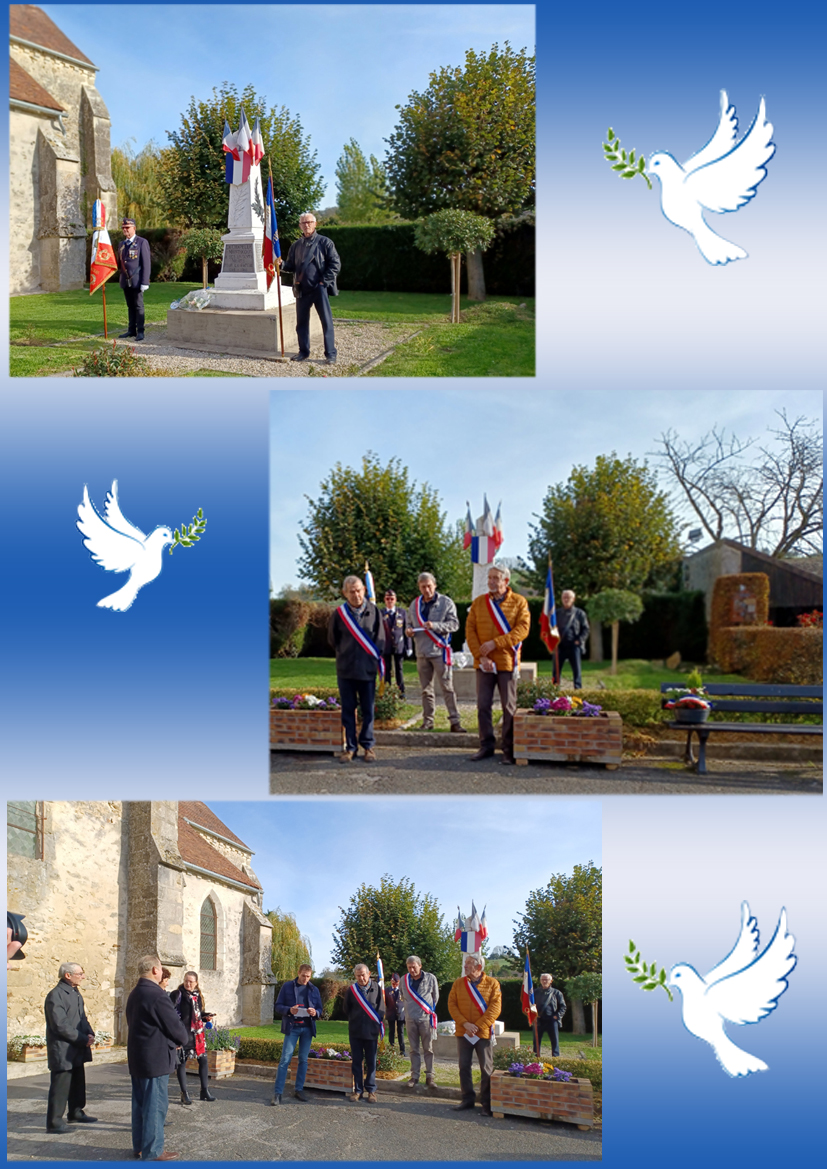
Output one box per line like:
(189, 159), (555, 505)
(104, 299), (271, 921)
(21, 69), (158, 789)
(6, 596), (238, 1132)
(77, 479), (173, 613)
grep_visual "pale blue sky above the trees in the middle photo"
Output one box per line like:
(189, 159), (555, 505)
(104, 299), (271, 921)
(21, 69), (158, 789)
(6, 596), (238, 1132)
(270, 381), (822, 590)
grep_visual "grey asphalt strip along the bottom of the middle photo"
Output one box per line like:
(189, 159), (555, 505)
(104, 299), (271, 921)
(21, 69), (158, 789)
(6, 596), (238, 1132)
(270, 736), (822, 796)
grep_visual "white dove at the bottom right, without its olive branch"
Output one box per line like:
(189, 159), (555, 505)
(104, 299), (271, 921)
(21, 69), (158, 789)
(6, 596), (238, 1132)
(669, 901), (797, 1075)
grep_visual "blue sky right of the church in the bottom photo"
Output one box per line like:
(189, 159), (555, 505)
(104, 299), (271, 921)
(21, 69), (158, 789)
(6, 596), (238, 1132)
(209, 796), (601, 973)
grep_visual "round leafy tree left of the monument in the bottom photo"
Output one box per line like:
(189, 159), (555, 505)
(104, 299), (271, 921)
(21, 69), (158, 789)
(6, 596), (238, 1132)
(331, 873), (460, 984)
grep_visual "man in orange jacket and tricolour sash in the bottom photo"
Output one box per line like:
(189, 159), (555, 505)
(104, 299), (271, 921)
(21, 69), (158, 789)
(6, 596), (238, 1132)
(448, 954), (502, 1116)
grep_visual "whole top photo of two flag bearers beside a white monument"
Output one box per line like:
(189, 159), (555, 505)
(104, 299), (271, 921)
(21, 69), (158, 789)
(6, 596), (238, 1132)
(9, 5), (536, 378)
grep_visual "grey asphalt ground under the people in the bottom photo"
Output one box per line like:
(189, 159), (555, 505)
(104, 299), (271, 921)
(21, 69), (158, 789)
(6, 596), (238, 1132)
(7, 1064), (602, 1162)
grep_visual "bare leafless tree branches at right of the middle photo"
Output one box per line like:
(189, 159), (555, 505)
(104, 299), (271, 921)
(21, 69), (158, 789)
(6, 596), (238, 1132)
(654, 410), (823, 556)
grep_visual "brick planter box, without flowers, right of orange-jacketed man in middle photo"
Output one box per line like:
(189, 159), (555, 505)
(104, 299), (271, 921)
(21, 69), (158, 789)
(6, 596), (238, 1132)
(514, 711), (623, 770)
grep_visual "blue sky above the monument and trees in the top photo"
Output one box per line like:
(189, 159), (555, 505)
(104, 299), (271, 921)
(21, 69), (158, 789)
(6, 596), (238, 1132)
(42, 5), (535, 206)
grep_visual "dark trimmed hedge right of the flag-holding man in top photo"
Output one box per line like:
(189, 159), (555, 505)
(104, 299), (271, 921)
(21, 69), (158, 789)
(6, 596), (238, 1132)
(319, 223), (535, 296)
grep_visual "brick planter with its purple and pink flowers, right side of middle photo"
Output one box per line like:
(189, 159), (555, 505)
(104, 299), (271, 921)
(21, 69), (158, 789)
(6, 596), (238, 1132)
(514, 687), (623, 769)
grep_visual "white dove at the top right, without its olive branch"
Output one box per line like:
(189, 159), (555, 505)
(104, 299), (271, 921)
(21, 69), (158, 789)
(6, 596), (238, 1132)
(648, 89), (776, 264)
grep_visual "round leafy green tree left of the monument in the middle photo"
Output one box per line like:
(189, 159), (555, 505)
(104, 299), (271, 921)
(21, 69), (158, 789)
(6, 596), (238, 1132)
(298, 451), (471, 603)
